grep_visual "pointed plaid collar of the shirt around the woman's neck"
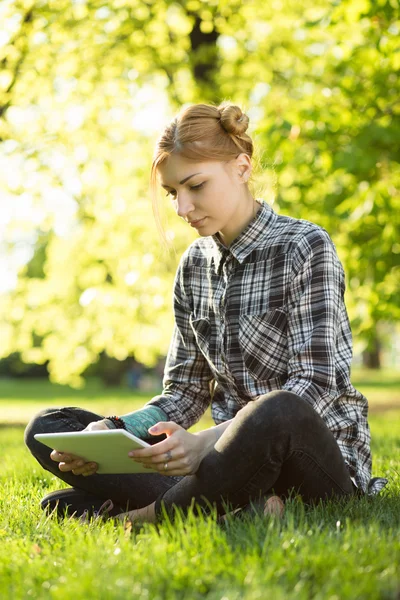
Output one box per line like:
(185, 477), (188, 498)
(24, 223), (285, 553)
(210, 200), (277, 273)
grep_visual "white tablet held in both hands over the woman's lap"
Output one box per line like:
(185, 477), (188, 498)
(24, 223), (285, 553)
(35, 429), (157, 475)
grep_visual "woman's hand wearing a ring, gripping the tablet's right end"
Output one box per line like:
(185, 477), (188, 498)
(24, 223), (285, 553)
(129, 421), (205, 475)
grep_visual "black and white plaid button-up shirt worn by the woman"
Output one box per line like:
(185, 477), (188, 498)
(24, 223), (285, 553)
(150, 201), (378, 491)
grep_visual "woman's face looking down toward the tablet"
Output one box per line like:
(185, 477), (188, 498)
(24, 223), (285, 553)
(158, 154), (253, 245)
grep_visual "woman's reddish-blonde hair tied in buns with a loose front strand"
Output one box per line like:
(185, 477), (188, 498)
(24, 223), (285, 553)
(150, 102), (253, 240)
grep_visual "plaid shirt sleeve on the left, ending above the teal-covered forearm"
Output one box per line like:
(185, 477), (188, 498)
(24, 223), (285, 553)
(148, 257), (213, 429)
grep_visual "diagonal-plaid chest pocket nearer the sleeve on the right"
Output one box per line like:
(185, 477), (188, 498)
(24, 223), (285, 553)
(239, 309), (288, 380)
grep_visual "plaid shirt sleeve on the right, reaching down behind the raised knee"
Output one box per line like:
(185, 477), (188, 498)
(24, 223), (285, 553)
(283, 230), (347, 416)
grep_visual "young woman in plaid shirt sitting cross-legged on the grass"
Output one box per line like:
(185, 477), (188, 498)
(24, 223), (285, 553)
(26, 104), (385, 521)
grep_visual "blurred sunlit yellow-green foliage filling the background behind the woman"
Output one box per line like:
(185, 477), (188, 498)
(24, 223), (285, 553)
(0, 0), (400, 386)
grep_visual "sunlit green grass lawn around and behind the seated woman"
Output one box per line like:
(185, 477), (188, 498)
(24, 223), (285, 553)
(0, 373), (400, 600)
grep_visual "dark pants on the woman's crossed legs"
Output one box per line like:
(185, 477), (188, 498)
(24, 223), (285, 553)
(25, 391), (354, 516)
